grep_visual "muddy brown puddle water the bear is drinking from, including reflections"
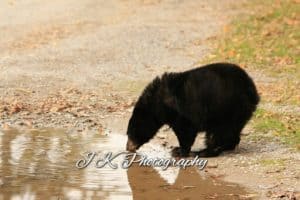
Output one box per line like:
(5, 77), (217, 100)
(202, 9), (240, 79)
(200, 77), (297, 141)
(0, 130), (253, 200)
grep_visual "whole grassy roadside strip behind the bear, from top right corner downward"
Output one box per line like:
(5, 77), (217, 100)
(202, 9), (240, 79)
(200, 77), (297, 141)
(205, 0), (300, 150)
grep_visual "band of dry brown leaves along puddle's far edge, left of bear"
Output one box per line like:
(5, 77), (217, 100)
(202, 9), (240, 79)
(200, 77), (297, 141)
(0, 88), (135, 116)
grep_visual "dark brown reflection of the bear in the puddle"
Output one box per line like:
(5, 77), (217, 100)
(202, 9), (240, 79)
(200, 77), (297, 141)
(127, 163), (247, 200)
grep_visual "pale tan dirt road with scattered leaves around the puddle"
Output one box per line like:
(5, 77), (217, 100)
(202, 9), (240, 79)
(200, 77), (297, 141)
(0, 0), (299, 197)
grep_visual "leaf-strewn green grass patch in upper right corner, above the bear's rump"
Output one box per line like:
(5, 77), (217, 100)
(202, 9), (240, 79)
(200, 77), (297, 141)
(205, 0), (300, 80)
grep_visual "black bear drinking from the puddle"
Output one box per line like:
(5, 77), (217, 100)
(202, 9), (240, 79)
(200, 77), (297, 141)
(126, 63), (259, 157)
